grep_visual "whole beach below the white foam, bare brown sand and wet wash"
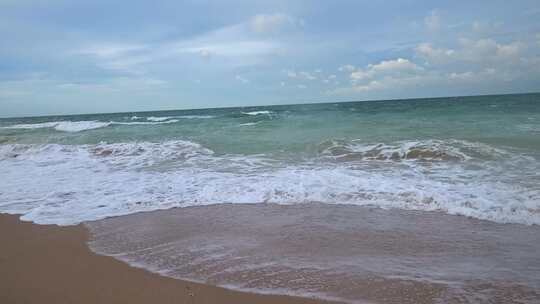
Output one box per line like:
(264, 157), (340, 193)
(4, 203), (540, 304)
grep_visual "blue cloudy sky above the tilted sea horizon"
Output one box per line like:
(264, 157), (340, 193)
(0, 0), (540, 117)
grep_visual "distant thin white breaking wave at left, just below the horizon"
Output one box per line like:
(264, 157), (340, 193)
(3, 119), (179, 132)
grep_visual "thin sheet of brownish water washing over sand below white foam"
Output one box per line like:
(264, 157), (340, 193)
(87, 204), (540, 303)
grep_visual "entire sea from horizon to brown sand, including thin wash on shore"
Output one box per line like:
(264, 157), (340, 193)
(0, 94), (540, 303)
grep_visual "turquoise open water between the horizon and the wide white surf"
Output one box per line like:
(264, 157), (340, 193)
(0, 94), (540, 154)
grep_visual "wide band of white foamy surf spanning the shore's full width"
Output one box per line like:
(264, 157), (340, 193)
(0, 140), (540, 225)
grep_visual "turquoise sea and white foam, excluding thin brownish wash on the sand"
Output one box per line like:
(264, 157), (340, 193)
(0, 94), (540, 224)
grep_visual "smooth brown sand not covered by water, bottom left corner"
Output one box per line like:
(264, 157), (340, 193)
(0, 214), (330, 304)
